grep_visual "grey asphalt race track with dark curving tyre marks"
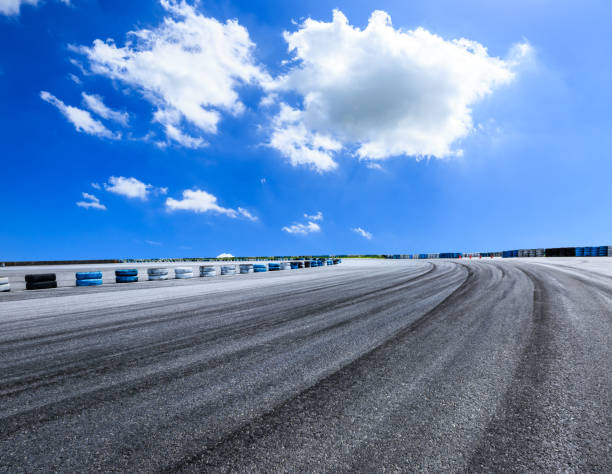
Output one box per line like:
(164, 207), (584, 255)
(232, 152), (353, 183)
(0, 258), (612, 473)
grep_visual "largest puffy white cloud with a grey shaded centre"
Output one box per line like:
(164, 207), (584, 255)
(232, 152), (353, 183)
(264, 10), (529, 171)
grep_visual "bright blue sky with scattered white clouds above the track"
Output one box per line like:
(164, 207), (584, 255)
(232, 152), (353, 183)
(0, 0), (612, 260)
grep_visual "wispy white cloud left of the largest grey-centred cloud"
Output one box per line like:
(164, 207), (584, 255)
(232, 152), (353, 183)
(77, 0), (267, 148)
